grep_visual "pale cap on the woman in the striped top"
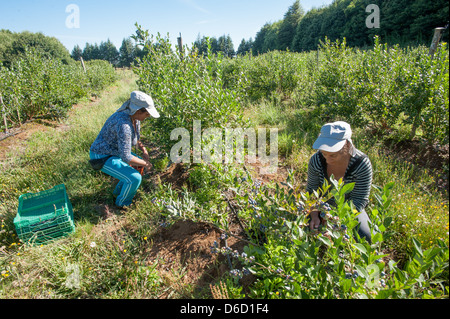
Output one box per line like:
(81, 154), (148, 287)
(313, 121), (354, 153)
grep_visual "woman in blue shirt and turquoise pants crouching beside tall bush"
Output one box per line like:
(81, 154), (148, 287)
(90, 91), (159, 207)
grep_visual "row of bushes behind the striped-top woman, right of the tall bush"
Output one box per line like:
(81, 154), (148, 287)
(223, 38), (449, 144)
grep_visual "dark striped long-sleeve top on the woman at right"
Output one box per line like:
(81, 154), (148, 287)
(306, 150), (373, 211)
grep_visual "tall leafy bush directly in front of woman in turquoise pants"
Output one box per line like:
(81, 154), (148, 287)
(134, 26), (248, 153)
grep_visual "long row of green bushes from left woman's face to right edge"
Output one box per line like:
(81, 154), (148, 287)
(135, 22), (449, 148)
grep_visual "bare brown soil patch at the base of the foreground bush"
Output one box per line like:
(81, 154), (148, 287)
(148, 220), (246, 298)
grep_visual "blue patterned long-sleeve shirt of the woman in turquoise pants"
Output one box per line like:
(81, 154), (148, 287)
(90, 112), (140, 163)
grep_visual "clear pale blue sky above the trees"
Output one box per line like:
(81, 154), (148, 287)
(0, 0), (332, 51)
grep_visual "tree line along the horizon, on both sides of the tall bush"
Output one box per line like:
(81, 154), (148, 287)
(0, 0), (449, 67)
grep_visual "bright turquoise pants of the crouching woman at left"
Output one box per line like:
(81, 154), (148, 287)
(89, 152), (142, 207)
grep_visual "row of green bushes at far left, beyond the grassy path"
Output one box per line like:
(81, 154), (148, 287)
(0, 49), (117, 129)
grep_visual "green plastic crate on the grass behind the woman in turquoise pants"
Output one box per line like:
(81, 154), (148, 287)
(14, 184), (75, 244)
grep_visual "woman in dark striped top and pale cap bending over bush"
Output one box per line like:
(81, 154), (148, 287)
(306, 121), (373, 242)
